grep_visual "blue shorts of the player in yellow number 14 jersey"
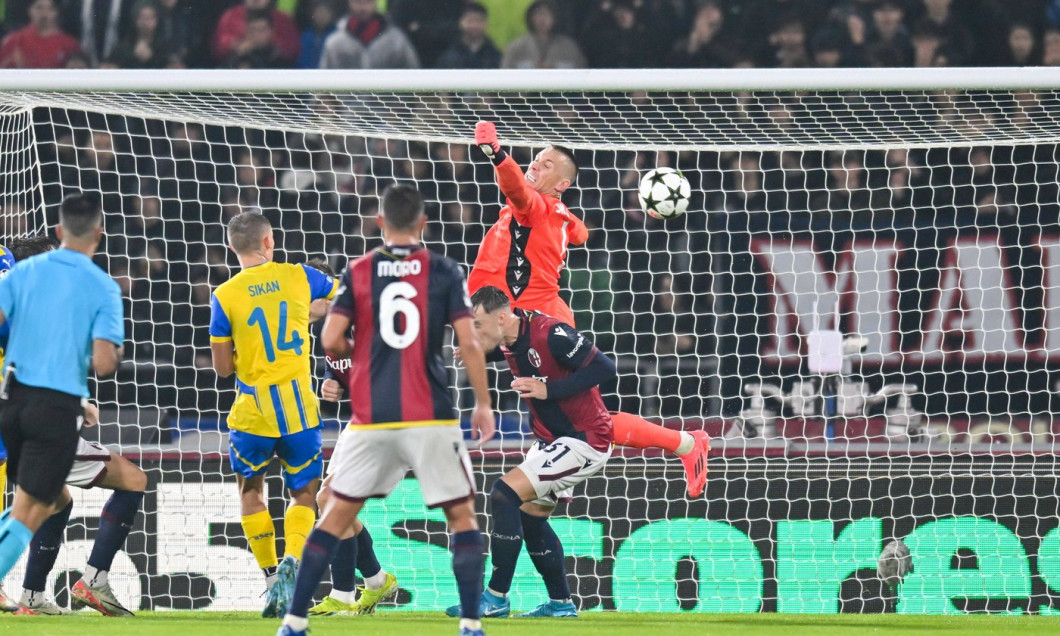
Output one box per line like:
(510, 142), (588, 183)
(228, 426), (324, 490)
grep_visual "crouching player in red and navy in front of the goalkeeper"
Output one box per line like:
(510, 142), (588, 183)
(446, 285), (616, 617)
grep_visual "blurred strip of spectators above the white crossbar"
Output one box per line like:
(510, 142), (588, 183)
(0, 0), (1060, 69)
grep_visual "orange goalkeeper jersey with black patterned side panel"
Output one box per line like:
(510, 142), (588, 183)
(467, 157), (588, 310)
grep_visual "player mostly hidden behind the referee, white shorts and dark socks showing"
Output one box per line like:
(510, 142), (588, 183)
(0, 236), (147, 616)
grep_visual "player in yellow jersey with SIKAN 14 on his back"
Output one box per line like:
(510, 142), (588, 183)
(210, 213), (338, 617)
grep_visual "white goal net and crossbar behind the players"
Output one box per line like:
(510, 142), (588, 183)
(0, 69), (1060, 614)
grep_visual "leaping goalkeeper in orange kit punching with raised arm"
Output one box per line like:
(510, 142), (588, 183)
(467, 122), (710, 497)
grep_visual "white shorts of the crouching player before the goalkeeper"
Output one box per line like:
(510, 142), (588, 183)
(519, 437), (612, 507)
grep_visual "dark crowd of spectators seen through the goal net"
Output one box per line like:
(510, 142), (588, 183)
(33, 91), (1060, 423)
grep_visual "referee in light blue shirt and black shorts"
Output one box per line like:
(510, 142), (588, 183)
(0, 194), (125, 579)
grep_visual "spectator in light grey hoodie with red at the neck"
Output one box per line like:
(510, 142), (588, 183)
(320, 0), (420, 69)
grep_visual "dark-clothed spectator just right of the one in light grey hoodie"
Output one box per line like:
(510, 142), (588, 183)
(387, 0), (465, 68)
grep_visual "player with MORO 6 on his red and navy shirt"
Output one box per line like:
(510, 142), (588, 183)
(278, 186), (495, 636)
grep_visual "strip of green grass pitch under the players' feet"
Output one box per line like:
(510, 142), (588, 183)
(0, 612), (1060, 636)
